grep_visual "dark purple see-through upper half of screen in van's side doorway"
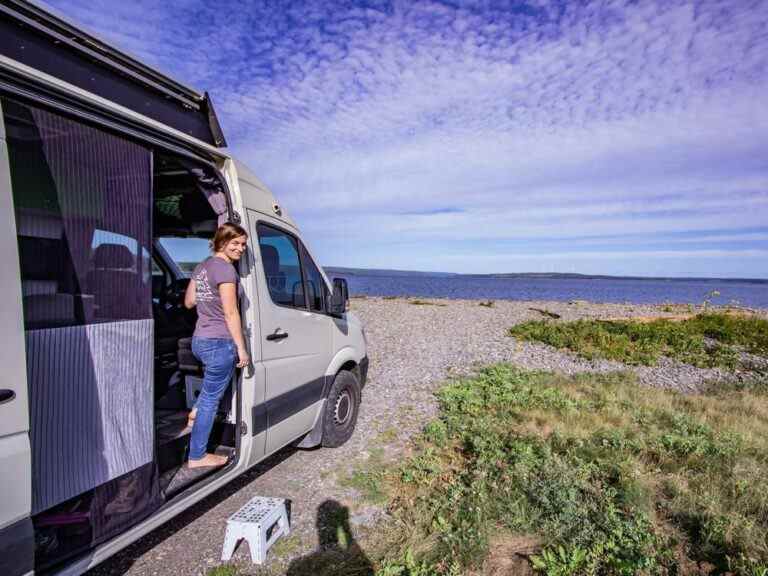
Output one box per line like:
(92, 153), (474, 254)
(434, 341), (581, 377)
(2, 98), (152, 330)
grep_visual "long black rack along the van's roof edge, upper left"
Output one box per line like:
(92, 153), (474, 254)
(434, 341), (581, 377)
(0, 0), (227, 147)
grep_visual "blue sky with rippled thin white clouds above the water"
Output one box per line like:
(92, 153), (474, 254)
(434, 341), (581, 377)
(40, 0), (768, 278)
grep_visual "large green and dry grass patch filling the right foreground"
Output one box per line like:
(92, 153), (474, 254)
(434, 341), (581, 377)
(379, 365), (768, 576)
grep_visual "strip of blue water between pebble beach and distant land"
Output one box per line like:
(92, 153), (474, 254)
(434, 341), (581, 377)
(329, 271), (768, 308)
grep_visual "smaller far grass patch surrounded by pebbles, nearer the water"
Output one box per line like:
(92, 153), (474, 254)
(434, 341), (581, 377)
(509, 313), (768, 369)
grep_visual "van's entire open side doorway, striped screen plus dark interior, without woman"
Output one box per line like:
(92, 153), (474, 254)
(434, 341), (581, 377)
(2, 98), (239, 573)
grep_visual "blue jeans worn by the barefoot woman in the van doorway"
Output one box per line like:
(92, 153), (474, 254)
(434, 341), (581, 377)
(189, 338), (237, 460)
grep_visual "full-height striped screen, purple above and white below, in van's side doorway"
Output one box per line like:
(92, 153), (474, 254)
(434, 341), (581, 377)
(2, 99), (156, 567)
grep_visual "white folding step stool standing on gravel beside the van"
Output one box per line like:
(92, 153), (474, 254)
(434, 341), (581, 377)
(221, 496), (291, 564)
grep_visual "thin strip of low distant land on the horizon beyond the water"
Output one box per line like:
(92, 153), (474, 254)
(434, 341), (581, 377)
(323, 266), (768, 284)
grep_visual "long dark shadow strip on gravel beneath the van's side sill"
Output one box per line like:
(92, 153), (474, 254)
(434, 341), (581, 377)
(85, 446), (298, 576)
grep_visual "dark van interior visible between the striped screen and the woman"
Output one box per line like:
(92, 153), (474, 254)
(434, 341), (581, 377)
(152, 153), (237, 498)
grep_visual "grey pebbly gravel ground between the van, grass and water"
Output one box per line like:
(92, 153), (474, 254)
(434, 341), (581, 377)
(90, 298), (768, 576)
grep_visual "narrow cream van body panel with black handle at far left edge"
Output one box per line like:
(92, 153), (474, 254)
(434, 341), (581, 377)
(0, 98), (34, 576)
